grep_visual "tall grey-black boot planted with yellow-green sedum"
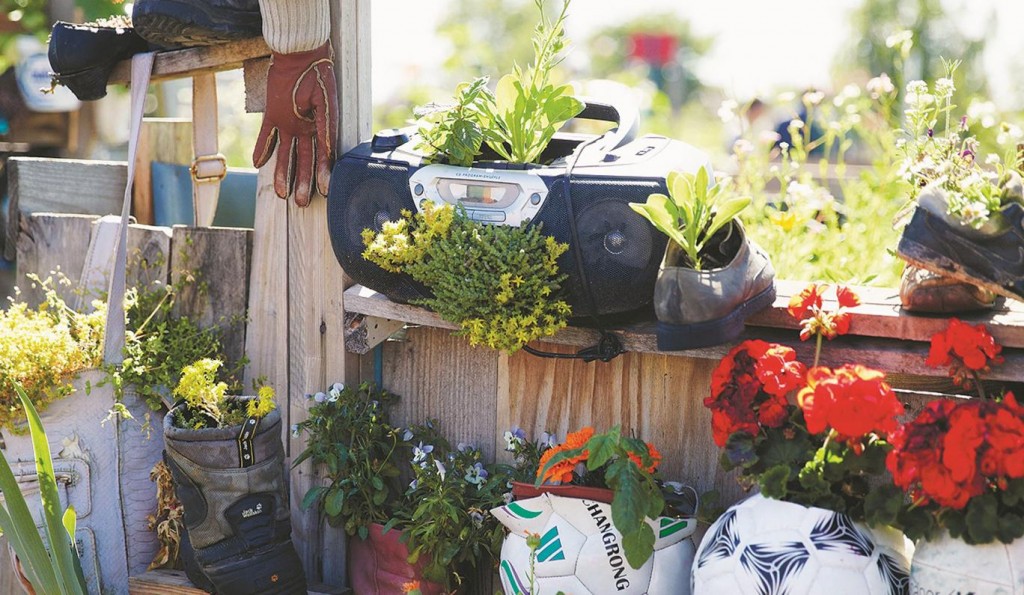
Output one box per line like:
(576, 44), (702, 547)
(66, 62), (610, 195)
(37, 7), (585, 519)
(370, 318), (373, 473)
(164, 397), (306, 595)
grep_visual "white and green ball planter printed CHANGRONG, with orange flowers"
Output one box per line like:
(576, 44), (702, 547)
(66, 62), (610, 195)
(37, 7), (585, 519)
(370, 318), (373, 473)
(490, 494), (696, 595)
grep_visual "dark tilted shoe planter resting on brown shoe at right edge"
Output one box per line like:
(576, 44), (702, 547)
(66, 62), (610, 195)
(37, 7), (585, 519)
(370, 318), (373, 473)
(897, 186), (1024, 301)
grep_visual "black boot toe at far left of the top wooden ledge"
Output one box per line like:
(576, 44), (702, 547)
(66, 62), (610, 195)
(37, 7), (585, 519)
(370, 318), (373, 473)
(47, 17), (150, 101)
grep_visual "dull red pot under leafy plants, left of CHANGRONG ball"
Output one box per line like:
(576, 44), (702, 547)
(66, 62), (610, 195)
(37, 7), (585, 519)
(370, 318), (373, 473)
(348, 523), (444, 595)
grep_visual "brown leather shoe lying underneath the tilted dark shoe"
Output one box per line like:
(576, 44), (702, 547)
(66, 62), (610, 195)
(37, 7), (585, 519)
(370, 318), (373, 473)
(899, 264), (995, 314)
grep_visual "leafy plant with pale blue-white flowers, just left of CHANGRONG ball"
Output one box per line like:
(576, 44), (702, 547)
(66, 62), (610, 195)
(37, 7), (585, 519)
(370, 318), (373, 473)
(385, 420), (512, 591)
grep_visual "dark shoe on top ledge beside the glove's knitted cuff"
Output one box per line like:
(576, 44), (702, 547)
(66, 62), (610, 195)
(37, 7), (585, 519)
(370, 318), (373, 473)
(132, 0), (263, 48)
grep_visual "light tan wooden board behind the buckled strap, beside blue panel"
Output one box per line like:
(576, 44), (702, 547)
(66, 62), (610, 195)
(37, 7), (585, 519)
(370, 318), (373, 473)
(132, 118), (193, 224)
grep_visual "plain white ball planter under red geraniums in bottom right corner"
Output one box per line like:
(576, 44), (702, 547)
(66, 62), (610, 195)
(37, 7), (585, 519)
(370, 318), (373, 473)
(910, 533), (1024, 595)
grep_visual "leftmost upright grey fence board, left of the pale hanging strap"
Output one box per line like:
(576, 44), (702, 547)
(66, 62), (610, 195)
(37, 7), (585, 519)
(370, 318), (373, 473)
(15, 213), (96, 306)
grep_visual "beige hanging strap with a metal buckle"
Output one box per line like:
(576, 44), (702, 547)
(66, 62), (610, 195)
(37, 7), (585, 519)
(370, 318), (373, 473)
(189, 73), (227, 227)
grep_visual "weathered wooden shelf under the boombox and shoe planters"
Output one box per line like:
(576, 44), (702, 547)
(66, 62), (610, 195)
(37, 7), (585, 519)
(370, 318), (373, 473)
(345, 282), (1024, 382)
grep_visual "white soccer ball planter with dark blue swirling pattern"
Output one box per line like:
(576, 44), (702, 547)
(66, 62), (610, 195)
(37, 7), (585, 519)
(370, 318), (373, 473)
(693, 495), (910, 595)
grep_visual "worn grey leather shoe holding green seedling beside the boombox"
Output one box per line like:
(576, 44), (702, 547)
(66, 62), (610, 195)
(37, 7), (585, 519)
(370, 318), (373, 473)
(654, 221), (775, 351)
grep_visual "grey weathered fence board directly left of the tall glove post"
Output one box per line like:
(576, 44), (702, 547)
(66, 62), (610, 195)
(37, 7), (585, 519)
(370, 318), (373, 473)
(171, 225), (253, 372)
